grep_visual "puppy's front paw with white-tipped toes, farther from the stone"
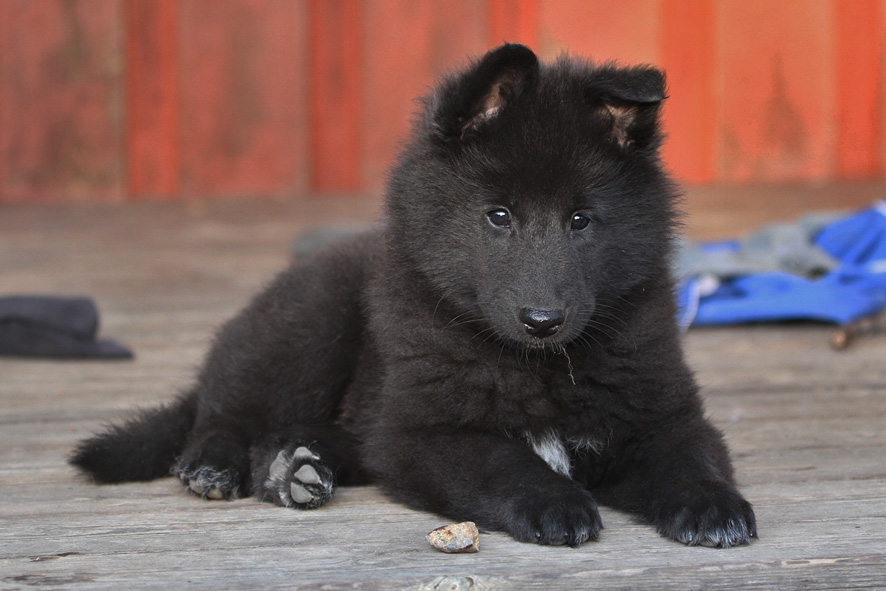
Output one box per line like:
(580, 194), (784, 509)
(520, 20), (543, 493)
(655, 485), (757, 548)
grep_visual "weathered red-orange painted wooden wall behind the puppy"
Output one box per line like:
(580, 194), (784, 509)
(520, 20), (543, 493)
(0, 0), (886, 202)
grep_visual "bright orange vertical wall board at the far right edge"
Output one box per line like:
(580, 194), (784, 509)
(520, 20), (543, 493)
(836, 0), (883, 178)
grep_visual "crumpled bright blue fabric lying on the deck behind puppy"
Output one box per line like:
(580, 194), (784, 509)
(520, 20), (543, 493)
(678, 202), (886, 326)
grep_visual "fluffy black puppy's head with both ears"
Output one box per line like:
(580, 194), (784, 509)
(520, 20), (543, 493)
(388, 44), (674, 348)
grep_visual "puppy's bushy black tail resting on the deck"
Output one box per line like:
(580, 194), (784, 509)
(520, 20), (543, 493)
(68, 392), (197, 484)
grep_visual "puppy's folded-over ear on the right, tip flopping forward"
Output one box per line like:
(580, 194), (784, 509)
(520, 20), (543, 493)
(585, 66), (667, 149)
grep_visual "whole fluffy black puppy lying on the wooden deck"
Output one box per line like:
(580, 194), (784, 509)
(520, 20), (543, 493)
(71, 45), (756, 547)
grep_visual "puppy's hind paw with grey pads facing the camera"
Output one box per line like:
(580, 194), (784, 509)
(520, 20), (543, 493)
(262, 446), (333, 509)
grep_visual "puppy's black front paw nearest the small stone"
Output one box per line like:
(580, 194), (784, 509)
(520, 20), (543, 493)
(507, 490), (603, 548)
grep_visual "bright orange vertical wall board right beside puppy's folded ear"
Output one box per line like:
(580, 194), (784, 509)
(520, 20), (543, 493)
(661, 0), (717, 183)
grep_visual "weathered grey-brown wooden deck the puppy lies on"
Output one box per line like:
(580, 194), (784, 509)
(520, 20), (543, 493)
(0, 187), (886, 591)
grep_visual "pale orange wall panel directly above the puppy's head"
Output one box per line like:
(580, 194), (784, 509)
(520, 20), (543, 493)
(539, 0), (661, 64)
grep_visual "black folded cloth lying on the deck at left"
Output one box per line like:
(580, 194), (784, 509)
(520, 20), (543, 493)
(0, 296), (133, 359)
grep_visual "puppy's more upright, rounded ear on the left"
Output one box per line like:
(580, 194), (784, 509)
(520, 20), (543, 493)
(428, 43), (538, 141)
